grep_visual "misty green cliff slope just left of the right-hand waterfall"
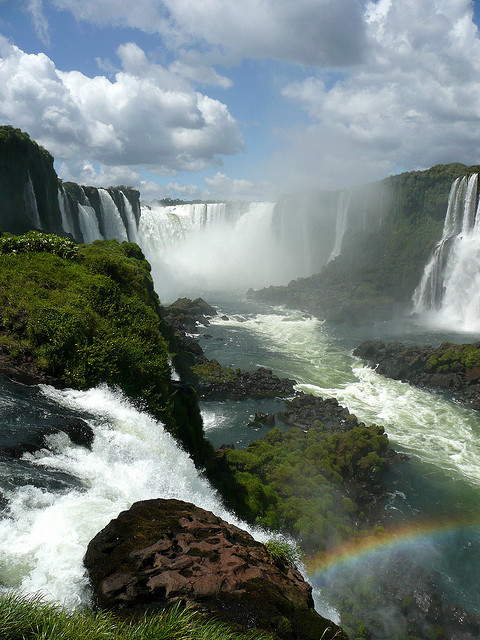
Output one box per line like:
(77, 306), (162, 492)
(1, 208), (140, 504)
(256, 164), (480, 323)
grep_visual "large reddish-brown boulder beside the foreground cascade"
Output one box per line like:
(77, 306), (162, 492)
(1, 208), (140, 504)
(84, 499), (347, 640)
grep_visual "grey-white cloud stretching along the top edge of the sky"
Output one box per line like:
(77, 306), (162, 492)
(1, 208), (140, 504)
(53, 0), (364, 66)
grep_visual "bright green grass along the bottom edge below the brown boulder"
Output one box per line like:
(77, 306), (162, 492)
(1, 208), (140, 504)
(0, 595), (271, 640)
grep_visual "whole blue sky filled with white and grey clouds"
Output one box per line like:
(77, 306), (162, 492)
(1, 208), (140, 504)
(0, 0), (480, 200)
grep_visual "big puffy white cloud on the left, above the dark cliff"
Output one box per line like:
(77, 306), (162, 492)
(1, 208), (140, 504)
(0, 36), (243, 175)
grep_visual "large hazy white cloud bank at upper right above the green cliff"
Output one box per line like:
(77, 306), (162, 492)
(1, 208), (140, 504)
(277, 0), (480, 186)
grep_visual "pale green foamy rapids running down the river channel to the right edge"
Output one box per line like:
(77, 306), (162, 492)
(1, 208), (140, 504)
(213, 311), (480, 484)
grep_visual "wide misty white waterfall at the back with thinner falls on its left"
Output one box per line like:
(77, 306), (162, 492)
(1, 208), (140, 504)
(52, 189), (350, 300)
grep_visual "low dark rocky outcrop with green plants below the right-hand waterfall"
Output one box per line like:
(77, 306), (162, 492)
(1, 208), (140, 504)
(353, 340), (480, 410)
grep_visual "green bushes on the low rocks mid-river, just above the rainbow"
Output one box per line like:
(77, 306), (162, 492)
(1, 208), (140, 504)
(219, 424), (388, 552)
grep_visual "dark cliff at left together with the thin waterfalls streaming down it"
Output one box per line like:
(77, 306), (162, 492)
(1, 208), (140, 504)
(0, 125), (140, 243)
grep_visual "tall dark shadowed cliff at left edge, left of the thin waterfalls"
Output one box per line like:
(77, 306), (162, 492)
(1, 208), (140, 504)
(0, 126), (62, 233)
